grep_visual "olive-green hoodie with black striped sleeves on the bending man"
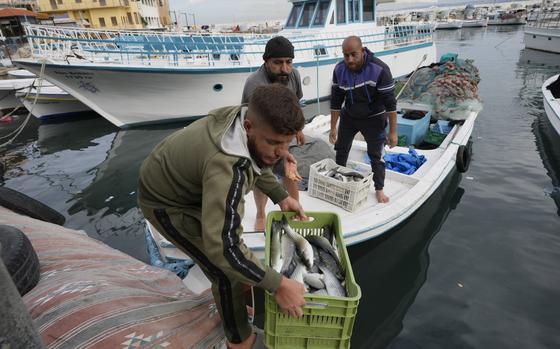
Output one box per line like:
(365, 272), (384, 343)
(138, 106), (288, 292)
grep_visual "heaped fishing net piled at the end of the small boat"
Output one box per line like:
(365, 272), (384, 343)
(400, 59), (482, 120)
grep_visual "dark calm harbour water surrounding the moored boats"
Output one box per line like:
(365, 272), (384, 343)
(0, 27), (560, 349)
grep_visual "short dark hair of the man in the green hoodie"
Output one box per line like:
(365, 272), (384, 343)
(249, 84), (305, 135)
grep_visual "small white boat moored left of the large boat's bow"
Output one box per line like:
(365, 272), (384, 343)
(16, 86), (92, 120)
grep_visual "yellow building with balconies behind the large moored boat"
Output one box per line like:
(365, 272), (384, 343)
(37, 0), (171, 29)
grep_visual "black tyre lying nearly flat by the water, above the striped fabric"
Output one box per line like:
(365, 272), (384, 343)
(0, 187), (66, 225)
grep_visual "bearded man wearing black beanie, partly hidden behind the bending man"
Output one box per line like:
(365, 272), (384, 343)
(241, 36), (305, 231)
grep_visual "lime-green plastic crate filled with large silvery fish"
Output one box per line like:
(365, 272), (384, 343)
(264, 211), (362, 349)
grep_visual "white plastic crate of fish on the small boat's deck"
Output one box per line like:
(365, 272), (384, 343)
(308, 159), (373, 212)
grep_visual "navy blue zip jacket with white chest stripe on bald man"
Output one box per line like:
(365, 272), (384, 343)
(331, 48), (397, 118)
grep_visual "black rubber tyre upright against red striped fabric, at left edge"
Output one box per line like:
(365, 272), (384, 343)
(0, 225), (40, 296)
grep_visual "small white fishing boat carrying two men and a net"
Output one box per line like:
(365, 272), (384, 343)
(148, 103), (478, 259)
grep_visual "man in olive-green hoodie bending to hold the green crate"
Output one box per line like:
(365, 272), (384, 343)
(138, 84), (306, 348)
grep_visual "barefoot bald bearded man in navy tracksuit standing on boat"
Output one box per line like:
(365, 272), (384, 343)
(329, 36), (397, 203)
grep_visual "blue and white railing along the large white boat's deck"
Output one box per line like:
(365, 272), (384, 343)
(21, 25), (432, 66)
